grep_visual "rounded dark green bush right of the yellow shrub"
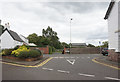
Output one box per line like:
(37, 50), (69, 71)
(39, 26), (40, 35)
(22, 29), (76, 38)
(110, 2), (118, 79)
(18, 50), (41, 59)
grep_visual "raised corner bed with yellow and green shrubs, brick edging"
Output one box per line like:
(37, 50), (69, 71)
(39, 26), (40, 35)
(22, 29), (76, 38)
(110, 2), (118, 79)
(0, 45), (43, 61)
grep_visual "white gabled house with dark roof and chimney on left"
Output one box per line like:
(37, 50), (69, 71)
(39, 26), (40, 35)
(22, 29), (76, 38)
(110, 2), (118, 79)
(0, 23), (24, 49)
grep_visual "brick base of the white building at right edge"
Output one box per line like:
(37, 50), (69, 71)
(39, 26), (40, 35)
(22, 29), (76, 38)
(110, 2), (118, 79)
(108, 50), (120, 62)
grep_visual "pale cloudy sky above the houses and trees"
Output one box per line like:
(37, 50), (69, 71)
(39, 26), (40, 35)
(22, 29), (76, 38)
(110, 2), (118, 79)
(0, 1), (109, 46)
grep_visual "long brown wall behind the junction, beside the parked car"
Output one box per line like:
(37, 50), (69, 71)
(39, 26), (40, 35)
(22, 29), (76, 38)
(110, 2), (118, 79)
(64, 47), (100, 54)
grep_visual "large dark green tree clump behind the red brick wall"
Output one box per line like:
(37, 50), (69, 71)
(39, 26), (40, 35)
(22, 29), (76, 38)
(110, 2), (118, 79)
(27, 26), (63, 49)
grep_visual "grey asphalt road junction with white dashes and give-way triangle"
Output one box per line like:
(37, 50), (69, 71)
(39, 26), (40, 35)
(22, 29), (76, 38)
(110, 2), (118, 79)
(2, 54), (119, 80)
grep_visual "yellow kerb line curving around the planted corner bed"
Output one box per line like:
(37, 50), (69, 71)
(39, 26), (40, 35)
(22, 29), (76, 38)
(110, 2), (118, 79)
(0, 57), (53, 67)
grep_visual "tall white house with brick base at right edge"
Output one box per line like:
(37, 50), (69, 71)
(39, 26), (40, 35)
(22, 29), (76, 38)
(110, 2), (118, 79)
(104, 0), (120, 61)
